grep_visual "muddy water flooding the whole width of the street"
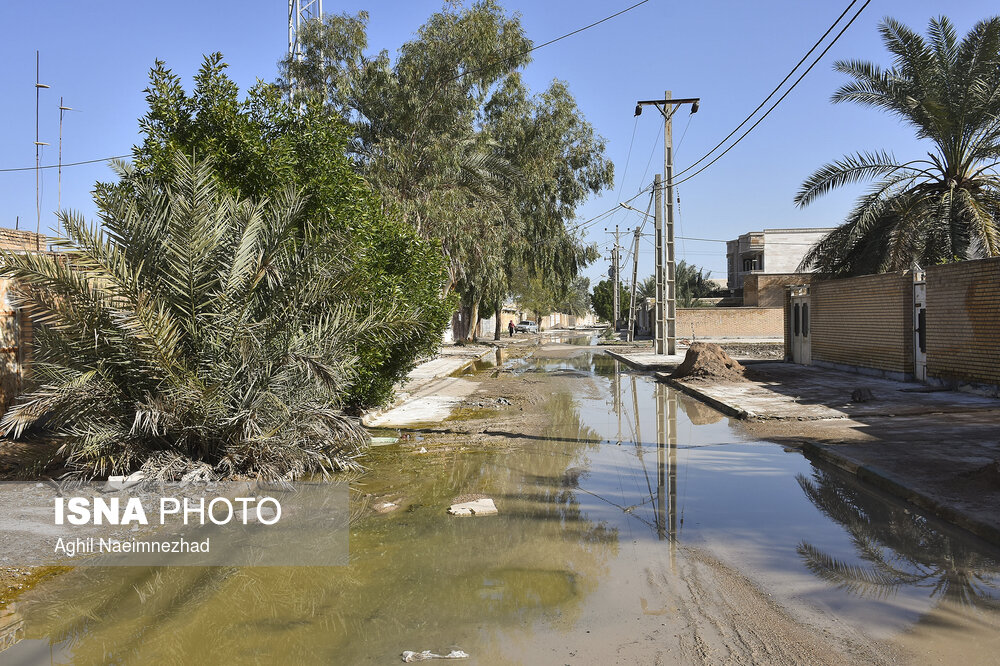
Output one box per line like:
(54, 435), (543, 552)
(0, 339), (1000, 664)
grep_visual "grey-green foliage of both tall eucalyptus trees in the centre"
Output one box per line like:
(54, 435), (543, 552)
(281, 0), (613, 338)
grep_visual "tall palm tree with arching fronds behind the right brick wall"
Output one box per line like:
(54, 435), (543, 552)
(795, 17), (1000, 275)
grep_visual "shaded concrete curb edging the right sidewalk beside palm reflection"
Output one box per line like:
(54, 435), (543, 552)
(802, 441), (1000, 546)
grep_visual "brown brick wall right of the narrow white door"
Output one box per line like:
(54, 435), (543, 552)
(926, 259), (1000, 385)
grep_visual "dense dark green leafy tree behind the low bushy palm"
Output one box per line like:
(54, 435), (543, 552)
(106, 54), (453, 405)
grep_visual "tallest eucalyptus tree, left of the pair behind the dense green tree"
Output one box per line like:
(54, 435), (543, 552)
(281, 0), (531, 292)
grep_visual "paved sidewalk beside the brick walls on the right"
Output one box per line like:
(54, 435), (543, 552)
(657, 363), (1000, 545)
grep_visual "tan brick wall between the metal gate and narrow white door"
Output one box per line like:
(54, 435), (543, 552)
(809, 272), (916, 376)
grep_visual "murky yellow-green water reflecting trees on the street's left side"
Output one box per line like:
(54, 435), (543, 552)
(0, 386), (618, 664)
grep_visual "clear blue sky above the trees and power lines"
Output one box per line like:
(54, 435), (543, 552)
(0, 0), (998, 280)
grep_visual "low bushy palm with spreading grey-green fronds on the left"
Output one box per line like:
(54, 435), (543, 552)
(2, 153), (428, 479)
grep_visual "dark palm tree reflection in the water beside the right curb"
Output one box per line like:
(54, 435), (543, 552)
(797, 469), (1000, 610)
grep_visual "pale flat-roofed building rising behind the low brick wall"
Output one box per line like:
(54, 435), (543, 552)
(726, 227), (833, 291)
